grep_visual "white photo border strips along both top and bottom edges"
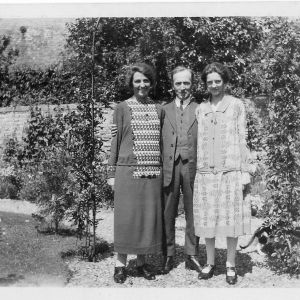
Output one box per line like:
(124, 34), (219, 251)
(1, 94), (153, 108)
(0, 0), (300, 300)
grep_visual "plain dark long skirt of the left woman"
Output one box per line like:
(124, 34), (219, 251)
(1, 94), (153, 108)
(114, 166), (163, 254)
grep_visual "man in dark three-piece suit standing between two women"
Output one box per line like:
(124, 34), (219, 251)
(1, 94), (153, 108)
(162, 66), (201, 273)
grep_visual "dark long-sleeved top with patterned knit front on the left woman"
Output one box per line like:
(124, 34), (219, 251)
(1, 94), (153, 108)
(109, 98), (161, 178)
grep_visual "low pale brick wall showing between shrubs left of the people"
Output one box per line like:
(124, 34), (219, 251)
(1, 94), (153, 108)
(0, 103), (114, 154)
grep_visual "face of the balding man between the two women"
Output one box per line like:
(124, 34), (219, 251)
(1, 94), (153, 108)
(173, 70), (192, 100)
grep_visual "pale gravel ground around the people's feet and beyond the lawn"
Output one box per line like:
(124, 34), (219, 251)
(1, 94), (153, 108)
(0, 200), (300, 288)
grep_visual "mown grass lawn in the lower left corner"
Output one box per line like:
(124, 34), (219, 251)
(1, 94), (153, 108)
(0, 212), (81, 287)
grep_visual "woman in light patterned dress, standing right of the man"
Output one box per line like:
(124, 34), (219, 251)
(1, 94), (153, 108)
(193, 63), (251, 284)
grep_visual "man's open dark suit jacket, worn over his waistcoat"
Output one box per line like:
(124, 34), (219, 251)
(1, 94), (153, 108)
(162, 101), (198, 187)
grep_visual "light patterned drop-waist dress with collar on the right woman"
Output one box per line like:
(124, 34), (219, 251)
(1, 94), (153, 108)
(193, 95), (252, 238)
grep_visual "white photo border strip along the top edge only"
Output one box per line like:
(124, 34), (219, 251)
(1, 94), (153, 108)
(0, 0), (300, 18)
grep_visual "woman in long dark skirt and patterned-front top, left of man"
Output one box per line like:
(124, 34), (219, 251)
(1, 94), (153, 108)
(108, 63), (162, 283)
